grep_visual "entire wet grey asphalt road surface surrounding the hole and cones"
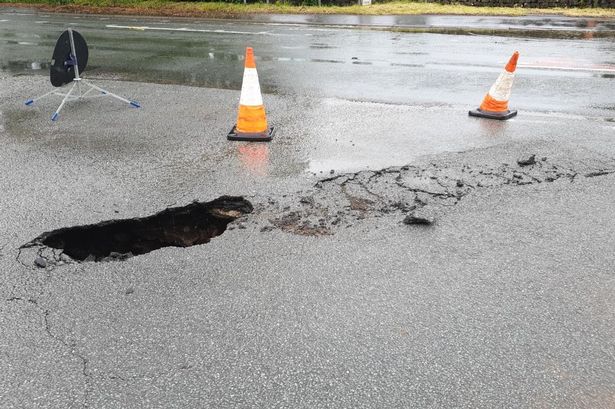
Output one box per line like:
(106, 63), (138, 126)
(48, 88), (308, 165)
(0, 8), (615, 408)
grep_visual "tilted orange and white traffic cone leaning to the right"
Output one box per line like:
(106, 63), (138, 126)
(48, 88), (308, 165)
(470, 51), (519, 119)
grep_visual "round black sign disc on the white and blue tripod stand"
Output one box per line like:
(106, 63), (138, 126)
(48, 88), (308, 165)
(49, 30), (88, 87)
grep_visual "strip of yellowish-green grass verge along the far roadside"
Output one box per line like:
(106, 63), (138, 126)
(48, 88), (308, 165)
(0, 0), (615, 18)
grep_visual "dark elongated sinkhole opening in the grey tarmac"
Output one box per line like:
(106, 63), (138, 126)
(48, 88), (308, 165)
(22, 196), (253, 261)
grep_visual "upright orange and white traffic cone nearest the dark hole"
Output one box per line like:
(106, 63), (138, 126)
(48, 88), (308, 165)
(227, 47), (274, 141)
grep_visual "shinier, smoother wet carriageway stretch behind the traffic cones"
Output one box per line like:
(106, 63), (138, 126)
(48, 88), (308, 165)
(0, 9), (615, 172)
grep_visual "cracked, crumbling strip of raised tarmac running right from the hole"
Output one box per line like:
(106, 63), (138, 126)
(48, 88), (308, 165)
(261, 151), (615, 236)
